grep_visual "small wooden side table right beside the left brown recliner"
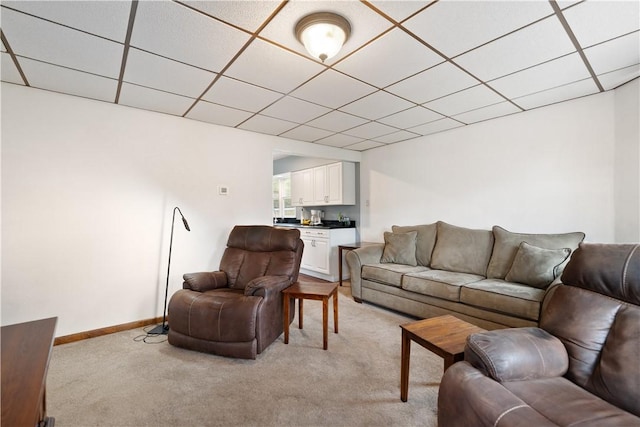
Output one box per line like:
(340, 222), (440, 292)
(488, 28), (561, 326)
(282, 282), (338, 350)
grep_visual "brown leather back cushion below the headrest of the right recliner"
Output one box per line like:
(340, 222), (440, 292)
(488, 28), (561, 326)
(540, 285), (640, 416)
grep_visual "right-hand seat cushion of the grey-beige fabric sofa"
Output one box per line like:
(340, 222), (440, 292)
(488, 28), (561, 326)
(460, 279), (545, 320)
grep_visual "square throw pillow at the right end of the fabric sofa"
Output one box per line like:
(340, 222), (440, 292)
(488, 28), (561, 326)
(504, 242), (571, 289)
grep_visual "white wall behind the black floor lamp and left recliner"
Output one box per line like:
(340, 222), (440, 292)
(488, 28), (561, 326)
(1, 83), (360, 336)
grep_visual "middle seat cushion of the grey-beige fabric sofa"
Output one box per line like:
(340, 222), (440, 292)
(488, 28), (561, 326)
(402, 270), (484, 302)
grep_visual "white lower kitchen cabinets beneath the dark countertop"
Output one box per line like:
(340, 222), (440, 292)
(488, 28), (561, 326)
(300, 228), (356, 282)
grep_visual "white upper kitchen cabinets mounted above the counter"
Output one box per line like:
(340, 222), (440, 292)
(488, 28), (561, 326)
(291, 162), (356, 206)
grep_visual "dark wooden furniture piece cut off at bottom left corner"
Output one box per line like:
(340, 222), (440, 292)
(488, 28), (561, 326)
(0, 317), (58, 427)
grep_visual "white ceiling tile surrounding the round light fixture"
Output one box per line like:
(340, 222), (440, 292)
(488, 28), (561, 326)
(260, 0), (392, 65)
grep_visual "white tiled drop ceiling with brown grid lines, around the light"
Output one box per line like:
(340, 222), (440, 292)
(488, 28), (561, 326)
(0, 0), (640, 151)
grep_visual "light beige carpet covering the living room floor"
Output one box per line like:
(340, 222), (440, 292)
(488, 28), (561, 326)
(47, 287), (443, 427)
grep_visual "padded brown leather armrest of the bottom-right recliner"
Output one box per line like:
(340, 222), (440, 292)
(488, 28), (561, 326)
(464, 327), (569, 382)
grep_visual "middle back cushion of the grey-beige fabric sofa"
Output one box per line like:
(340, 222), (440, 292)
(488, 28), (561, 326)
(431, 221), (493, 276)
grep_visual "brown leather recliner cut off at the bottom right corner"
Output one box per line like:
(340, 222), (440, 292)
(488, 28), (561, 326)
(438, 243), (640, 427)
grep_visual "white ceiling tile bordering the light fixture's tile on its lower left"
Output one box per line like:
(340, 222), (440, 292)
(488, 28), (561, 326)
(226, 40), (324, 93)
